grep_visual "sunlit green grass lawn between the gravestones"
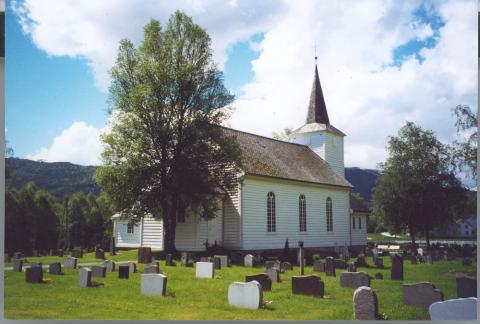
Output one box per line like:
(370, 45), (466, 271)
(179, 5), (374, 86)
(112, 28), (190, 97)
(4, 251), (476, 320)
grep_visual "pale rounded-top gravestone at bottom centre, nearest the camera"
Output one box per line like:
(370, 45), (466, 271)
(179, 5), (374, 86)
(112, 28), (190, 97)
(228, 281), (263, 309)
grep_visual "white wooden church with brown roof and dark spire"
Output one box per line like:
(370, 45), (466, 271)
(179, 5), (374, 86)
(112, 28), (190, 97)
(112, 66), (368, 251)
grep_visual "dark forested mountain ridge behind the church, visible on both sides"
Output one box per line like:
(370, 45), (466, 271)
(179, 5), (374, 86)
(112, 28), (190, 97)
(5, 158), (380, 202)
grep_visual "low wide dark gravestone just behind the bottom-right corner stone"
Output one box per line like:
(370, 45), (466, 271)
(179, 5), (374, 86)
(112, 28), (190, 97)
(403, 282), (443, 307)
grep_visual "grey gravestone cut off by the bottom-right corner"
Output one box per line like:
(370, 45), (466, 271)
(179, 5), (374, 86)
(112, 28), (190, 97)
(428, 297), (477, 321)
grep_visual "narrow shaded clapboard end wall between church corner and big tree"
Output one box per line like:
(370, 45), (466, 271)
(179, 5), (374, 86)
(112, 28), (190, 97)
(223, 185), (241, 249)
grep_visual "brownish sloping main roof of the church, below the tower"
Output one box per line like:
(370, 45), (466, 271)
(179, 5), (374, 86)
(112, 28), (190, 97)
(223, 127), (352, 188)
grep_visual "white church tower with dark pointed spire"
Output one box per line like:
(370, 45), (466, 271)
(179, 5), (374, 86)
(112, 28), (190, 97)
(291, 62), (345, 177)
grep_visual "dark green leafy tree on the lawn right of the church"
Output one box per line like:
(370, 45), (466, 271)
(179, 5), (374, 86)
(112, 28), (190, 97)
(373, 122), (467, 247)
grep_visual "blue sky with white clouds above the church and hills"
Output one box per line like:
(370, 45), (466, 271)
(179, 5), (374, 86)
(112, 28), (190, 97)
(6, 0), (478, 180)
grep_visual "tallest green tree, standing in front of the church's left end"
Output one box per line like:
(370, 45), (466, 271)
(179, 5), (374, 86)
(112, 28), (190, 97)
(95, 11), (240, 251)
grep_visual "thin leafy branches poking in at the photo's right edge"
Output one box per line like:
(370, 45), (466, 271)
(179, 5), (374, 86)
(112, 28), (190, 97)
(453, 105), (478, 179)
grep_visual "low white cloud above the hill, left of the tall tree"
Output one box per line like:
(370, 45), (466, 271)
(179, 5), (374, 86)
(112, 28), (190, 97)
(25, 121), (103, 165)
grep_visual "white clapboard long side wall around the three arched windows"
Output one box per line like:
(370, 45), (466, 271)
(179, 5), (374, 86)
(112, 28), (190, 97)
(242, 176), (350, 250)
